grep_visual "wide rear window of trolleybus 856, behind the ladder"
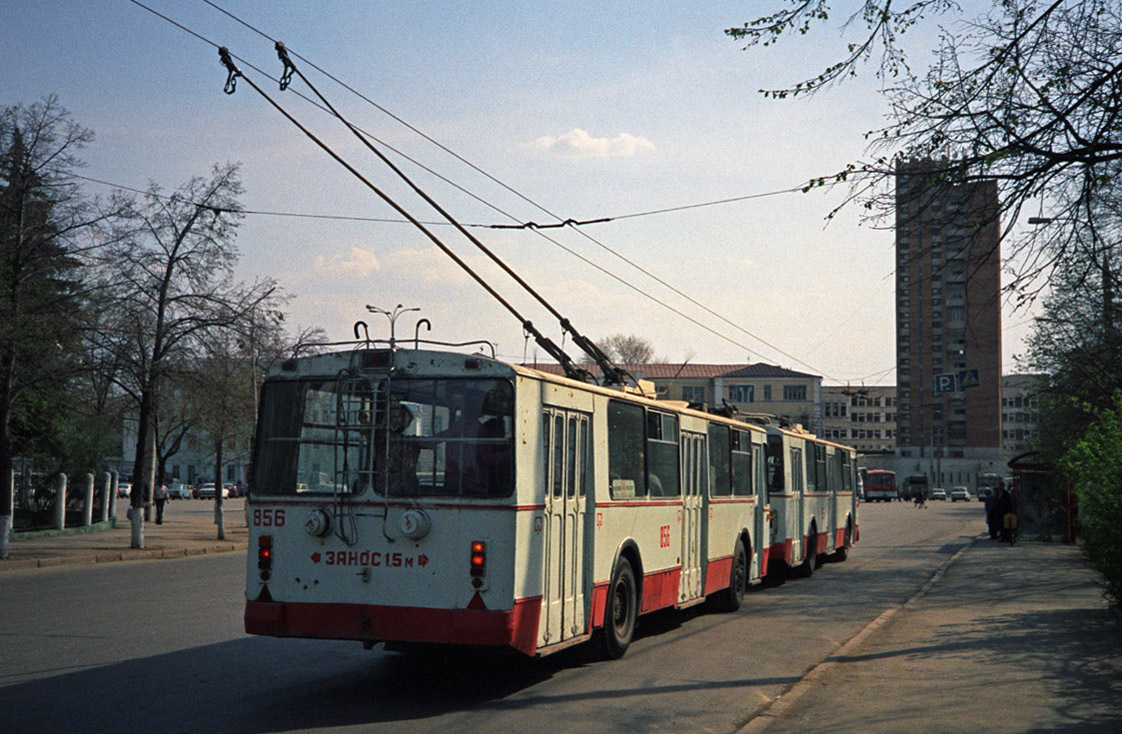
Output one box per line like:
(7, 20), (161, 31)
(252, 378), (514, 497)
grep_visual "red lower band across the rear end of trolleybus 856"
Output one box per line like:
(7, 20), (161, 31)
(245, 596), (542, 655)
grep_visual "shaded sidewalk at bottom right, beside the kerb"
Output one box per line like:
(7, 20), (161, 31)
(741, 538), (1122, 734)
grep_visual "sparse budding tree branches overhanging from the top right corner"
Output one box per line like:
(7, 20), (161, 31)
(726, 0), (1122, 300)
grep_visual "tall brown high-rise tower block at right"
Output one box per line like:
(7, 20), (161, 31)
(895, 160), (1002, 458)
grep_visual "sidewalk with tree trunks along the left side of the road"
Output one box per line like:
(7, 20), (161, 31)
(0, 498), (249, 572)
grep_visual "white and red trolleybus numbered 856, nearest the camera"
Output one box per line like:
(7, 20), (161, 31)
(245, 345), (856, 657)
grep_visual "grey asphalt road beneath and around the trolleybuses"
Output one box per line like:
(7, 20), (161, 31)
(0, 503), (983, 733)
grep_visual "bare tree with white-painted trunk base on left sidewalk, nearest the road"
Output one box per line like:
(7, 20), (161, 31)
(98, 165), (274, 548)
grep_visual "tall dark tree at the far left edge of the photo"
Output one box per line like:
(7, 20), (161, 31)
(0, 98), (99, 558)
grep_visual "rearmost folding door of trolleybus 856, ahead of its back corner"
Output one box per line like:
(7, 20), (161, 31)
(537, 409), (591, 646)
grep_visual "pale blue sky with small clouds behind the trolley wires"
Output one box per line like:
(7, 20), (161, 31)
(0, 0), (1030, 385)
